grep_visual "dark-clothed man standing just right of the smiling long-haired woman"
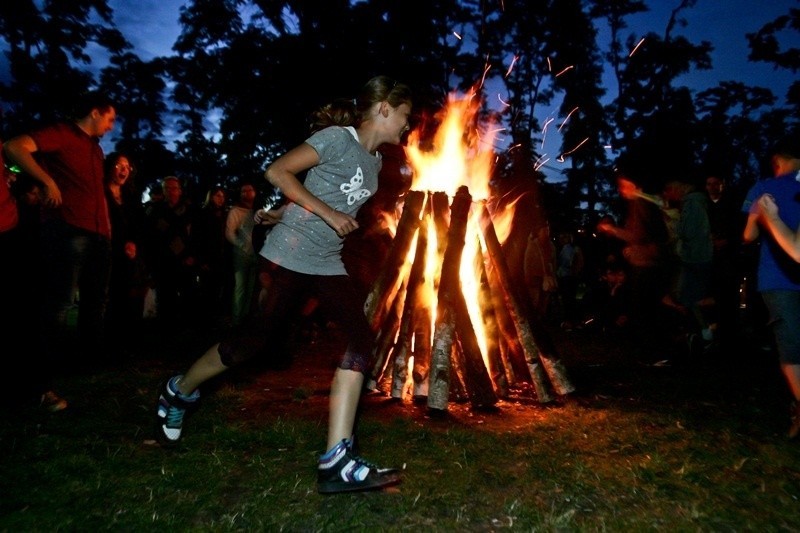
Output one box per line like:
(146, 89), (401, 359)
(145, 176), (197, 331)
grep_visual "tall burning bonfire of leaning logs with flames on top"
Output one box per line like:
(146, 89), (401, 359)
(365, 94), (574, 410)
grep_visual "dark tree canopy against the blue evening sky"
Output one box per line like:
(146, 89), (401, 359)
(0, 0), (800, 225)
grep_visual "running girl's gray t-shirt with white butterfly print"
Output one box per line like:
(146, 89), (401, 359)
(261, 126), (381, 276)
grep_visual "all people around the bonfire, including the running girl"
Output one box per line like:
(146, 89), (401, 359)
(0, 82), (800, 494)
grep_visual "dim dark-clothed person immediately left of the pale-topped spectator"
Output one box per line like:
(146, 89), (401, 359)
(192, 185), (232, 326)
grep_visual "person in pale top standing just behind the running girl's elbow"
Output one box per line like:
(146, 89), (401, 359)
(225, 181), (258, 327)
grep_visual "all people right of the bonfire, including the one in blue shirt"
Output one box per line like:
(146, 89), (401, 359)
(512, 136), (800, 438)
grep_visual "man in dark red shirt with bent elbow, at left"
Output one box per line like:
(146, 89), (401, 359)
(5, 93), (117, 408)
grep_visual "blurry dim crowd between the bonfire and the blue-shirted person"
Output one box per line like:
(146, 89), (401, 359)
(529, 173), (755, 362)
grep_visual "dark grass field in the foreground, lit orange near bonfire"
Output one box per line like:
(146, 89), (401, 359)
(0, 318), (800, 532)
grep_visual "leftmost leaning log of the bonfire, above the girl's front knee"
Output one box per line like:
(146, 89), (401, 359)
(364, 187), (425, 331)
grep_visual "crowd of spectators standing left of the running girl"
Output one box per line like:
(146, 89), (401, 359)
(0, 93), (279, 412)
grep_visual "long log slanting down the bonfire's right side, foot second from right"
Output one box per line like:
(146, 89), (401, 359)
(480, 204), (553, 403)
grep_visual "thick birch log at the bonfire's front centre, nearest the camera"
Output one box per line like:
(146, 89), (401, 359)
(428, 186), (472, 410)
